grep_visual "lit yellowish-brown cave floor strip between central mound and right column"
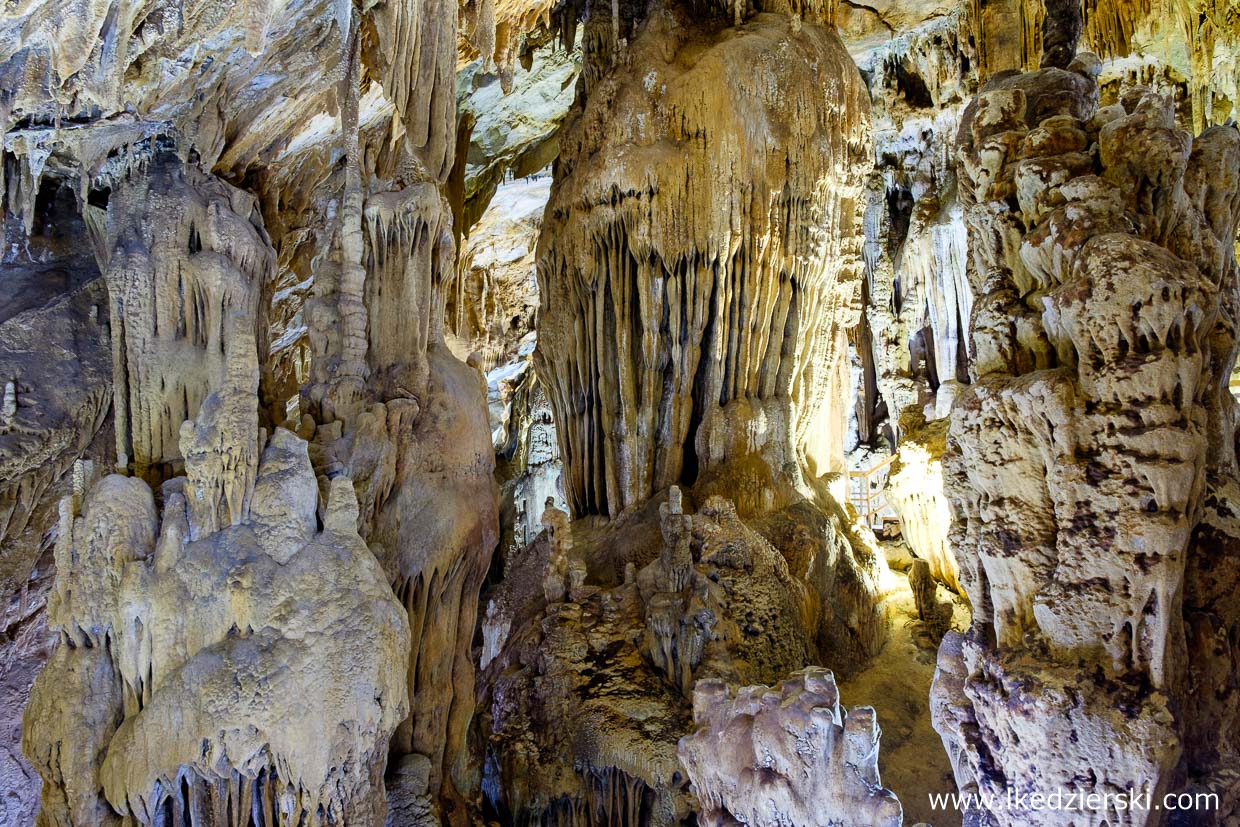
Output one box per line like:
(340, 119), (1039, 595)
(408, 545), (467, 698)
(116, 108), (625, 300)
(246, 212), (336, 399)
(839, 560), (970, 827)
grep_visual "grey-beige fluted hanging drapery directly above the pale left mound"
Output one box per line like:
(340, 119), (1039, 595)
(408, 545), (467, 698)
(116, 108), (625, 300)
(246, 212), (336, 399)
(104, 159), (274, 477)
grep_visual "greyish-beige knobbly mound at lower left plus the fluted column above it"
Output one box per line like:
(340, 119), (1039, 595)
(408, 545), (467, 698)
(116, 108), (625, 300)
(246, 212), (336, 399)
(25, 156), (409, 825)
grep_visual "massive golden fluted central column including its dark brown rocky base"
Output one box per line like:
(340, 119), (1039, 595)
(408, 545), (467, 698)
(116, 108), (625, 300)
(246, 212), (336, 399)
(480, 4), (898, 825)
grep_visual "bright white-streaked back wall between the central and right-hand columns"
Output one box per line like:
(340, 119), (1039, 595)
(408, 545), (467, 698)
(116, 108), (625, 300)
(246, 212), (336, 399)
(846, 7), (977, 450)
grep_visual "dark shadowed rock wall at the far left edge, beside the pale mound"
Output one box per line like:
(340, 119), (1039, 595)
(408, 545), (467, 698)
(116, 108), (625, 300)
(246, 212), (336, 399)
(0, 197), (114, 825)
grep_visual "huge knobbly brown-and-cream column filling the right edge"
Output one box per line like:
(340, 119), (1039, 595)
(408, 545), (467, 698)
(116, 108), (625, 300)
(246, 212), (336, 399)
(934, 24), (1240, 825)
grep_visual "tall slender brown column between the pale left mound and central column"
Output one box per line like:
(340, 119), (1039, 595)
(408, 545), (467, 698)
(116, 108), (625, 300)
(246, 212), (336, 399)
(295, 22), (498, 823)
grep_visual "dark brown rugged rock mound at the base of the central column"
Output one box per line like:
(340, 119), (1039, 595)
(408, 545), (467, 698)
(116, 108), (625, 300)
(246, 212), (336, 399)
(482, 497), (828, 825)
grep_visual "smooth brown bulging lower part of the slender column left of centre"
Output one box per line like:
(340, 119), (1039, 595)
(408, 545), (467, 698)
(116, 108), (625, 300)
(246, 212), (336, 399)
(301, 343), (498, 817)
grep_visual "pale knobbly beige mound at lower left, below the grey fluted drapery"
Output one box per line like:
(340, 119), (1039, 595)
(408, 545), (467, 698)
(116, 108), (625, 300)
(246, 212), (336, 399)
(24, 453), (409, 825)
